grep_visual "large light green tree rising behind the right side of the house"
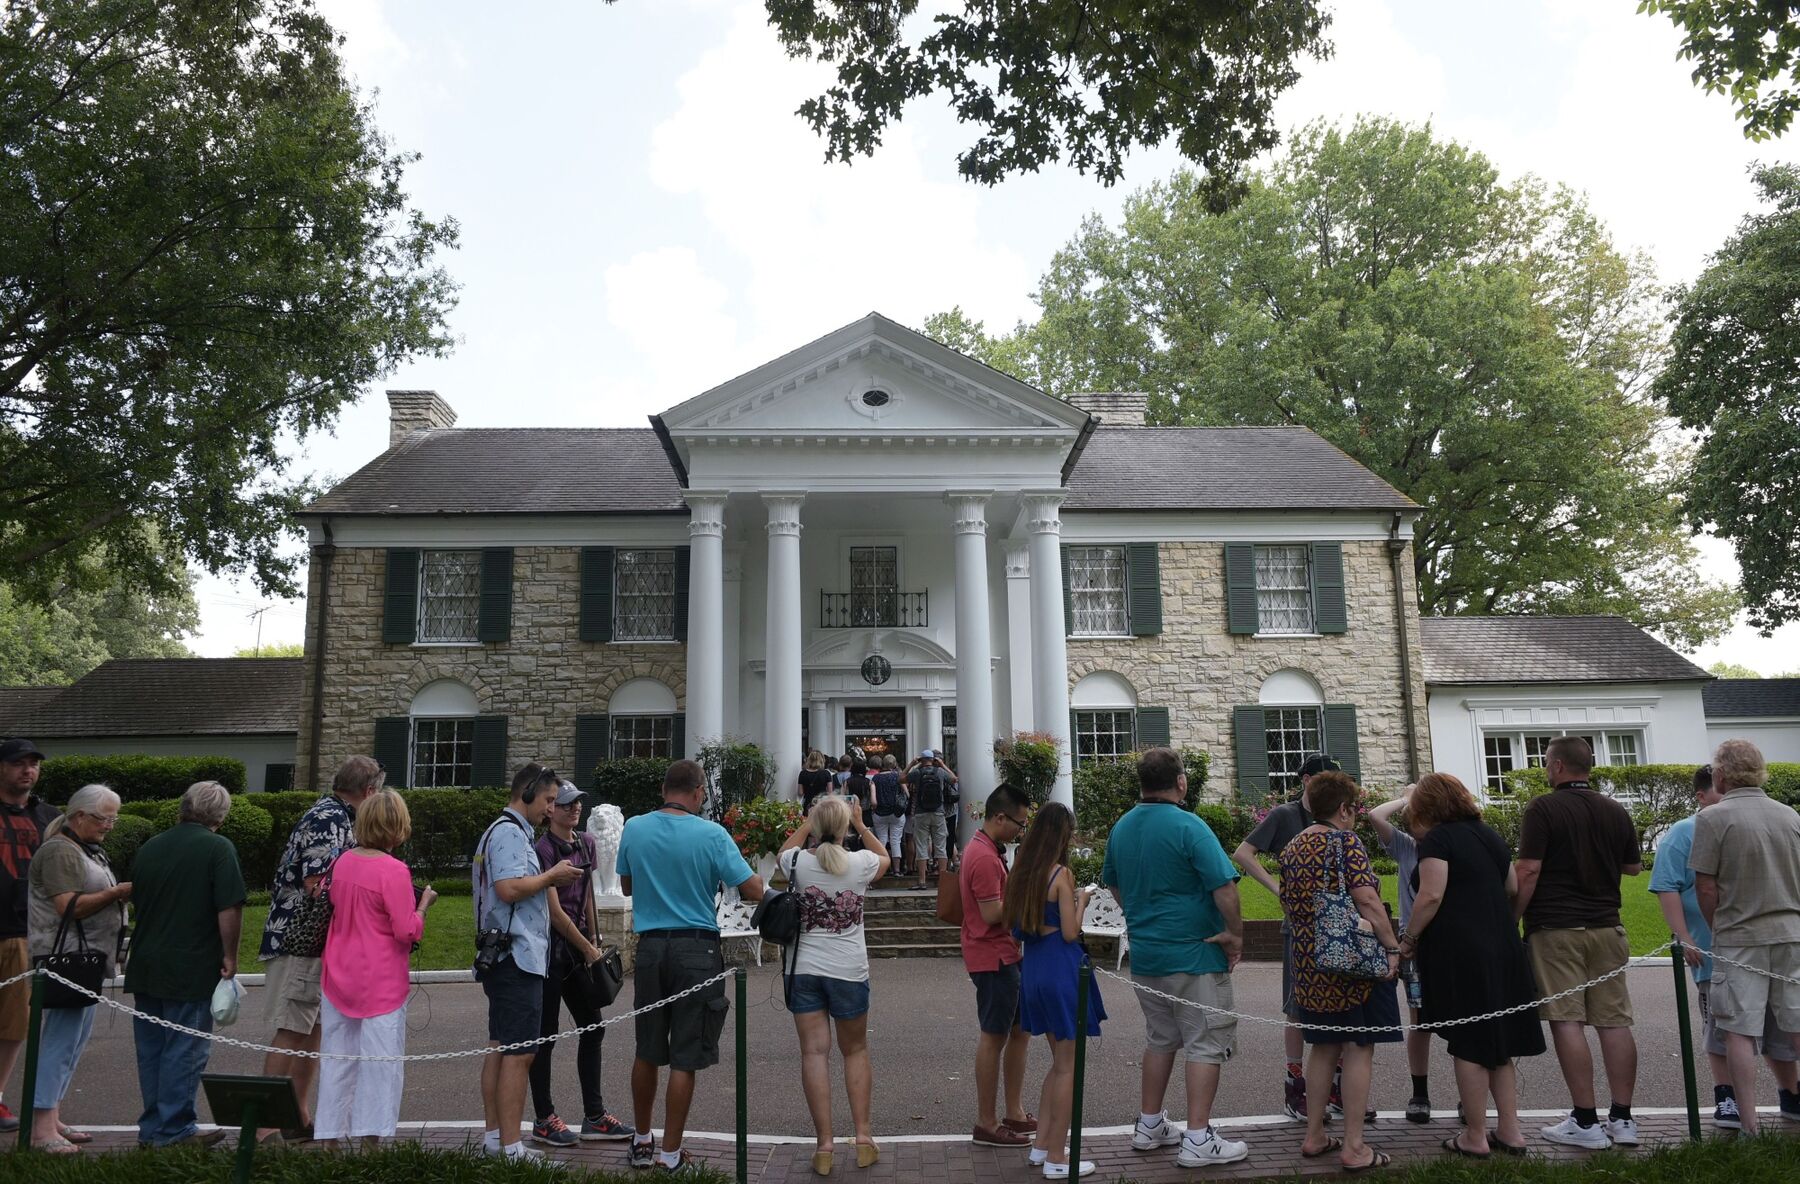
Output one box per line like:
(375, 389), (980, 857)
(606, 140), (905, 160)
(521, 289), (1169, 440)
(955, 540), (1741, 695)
(925, 119), (1737, 646)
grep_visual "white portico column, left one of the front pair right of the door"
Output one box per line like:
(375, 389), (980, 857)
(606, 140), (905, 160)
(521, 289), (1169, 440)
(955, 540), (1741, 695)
(945, 491), (995, 813)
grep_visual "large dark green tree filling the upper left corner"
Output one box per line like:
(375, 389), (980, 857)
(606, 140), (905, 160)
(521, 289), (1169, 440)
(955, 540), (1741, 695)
(0, 0), (455, 601)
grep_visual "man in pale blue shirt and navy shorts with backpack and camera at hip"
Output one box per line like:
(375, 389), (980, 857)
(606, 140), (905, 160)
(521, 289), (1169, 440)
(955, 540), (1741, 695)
(473, 761), (581, 1159)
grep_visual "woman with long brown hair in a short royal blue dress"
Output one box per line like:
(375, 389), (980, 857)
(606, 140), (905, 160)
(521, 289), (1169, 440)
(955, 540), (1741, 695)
(1004, 803), (1107, 1180)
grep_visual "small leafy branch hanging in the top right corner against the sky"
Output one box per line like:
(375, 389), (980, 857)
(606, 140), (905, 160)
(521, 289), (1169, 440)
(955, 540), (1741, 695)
(1638, 0), (1800, 140)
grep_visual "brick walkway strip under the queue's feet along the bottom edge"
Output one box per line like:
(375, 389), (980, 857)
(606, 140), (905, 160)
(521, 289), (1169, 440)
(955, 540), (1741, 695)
(66, 1114), (1771, 1184)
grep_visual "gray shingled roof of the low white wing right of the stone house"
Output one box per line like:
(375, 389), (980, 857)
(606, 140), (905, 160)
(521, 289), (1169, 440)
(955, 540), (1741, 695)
(1418, 617), (1712, 684)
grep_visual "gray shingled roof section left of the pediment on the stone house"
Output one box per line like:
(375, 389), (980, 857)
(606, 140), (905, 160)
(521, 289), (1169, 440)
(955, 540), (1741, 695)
(304, 428), (688, 515)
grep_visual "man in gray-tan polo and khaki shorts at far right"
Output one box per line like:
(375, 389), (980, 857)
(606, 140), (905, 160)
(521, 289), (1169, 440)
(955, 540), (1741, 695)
(1688, 740), (1800, 1135)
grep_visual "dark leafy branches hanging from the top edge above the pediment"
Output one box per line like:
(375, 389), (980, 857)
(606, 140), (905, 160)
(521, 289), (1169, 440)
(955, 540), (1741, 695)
(765, 0), (1330, 185)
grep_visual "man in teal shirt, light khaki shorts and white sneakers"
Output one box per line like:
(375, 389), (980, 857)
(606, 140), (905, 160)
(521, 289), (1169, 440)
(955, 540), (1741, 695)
(1100, 749), (1249, 1168)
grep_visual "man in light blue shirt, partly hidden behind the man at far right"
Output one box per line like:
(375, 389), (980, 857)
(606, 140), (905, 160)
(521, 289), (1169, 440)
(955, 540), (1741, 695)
(1651, 765), (1800, 1130)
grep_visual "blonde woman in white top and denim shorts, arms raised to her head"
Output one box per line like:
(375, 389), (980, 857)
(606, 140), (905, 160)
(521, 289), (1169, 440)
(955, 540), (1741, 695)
(778, 794), (889, 1175)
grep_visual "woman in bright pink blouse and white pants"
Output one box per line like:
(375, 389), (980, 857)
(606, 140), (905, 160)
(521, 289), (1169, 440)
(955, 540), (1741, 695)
(313, 790), (437, 1146)
